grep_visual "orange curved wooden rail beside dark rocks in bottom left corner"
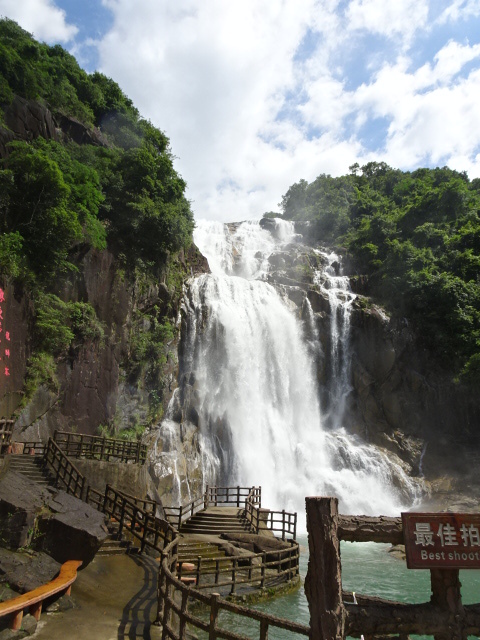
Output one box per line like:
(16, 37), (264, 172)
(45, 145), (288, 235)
(0, 560), (82, 630)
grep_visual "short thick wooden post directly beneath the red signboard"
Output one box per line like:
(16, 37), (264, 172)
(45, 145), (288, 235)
(430, 569), (467, 640)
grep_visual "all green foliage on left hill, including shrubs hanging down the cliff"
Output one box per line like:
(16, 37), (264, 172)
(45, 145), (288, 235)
(0, 19), (194, 419)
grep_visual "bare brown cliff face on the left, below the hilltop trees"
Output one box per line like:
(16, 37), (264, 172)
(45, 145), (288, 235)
(0, 238), (208, 441)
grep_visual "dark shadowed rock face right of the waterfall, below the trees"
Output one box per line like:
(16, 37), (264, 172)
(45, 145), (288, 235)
(348, 301), (480, 479)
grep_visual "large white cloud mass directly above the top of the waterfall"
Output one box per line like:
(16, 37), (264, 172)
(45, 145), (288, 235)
(99, 0), (336, 219)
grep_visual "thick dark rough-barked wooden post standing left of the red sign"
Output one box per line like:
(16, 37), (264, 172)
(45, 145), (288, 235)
(305, 498), (345, 640)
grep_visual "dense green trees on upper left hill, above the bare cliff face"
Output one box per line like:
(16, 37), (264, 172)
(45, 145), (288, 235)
(0, 19), (193, 283)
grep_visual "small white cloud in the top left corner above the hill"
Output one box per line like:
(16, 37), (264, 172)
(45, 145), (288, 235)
(0, 0), (78, 43)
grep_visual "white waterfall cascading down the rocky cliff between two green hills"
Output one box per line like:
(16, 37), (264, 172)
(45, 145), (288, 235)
(156, 220), (422, 514)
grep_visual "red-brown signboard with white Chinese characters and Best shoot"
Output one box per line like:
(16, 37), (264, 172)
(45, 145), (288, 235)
(402, 513), (480, 569)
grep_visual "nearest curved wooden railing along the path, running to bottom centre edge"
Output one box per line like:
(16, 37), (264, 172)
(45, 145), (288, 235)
(156, 539), (310, 640)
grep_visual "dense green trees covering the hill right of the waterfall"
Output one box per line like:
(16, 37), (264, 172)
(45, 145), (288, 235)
(280, 162), (480, 383)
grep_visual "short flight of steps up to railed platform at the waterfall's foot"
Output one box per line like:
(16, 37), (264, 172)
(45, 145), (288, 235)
(180, 507), (253, 536)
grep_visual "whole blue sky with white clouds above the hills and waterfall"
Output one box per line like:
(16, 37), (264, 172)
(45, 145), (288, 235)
(0, 0), (480, 222)
